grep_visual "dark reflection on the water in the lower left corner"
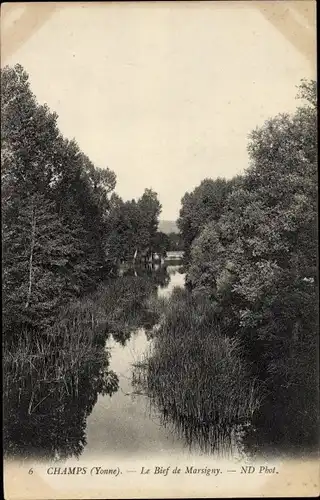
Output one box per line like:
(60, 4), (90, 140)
(4, 349), (118, 459)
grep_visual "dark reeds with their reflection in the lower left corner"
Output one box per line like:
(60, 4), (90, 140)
(3, 324), (118, 458)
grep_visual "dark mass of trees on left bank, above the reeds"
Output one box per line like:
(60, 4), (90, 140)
(1, 65), (165, 341)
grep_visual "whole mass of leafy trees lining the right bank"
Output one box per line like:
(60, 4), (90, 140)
(177, 81), (318, 448)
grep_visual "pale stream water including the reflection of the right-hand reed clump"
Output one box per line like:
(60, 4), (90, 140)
(83, 266), (248, 459)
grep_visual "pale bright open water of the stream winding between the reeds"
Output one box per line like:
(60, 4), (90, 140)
(82, 267), (249, 458)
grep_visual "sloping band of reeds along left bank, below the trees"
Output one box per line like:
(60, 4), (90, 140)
(4, 277), (155, 381)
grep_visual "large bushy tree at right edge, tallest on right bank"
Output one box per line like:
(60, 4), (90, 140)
(189, 82), (317, 369)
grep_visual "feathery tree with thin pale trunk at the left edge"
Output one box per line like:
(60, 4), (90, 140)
(3, 194), (87, 335)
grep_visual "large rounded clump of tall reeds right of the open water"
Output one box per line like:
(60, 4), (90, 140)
(136, 289), (262, 452)
